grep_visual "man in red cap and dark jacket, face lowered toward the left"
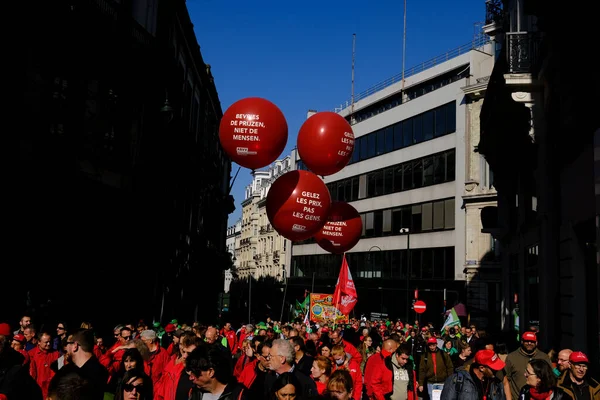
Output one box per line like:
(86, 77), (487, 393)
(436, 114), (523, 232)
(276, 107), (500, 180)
(441, 350), (506, 400)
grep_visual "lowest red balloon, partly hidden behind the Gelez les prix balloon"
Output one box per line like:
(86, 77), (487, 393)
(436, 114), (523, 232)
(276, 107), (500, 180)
(315, 201), (362, 254)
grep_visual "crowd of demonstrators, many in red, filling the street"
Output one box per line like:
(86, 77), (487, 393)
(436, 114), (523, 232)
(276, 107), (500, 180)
(0, 316), (600, 400)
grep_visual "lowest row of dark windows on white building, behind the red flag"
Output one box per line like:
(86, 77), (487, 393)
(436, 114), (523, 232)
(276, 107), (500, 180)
(292, 247), (454, 280)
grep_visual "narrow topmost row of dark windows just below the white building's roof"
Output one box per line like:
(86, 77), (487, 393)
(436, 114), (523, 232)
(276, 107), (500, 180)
(347, 66), (470, 122)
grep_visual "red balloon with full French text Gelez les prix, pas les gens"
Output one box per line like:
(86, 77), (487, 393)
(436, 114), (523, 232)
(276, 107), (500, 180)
(266, 170), (331, 241)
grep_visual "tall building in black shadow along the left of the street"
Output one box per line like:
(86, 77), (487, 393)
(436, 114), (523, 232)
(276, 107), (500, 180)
(8, 0), (234, 327)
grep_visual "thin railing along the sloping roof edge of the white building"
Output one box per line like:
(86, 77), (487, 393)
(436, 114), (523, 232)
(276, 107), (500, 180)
(335, 35), (489, 112)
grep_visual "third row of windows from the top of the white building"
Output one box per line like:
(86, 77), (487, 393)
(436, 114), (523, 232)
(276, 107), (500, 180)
(327, 149), (456, 202)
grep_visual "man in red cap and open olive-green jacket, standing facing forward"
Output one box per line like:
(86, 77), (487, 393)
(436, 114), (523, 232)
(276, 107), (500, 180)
(504, 332), (552, 400)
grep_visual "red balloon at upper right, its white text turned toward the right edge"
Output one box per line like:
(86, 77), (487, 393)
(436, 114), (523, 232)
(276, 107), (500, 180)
(298, 111), (354, 176)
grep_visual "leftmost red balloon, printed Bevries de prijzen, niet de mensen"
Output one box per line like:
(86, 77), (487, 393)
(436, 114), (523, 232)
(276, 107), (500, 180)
(219, 97), (288, 170)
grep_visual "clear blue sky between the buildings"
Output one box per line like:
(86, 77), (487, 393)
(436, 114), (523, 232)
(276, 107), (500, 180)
(187, 0), (485, 225)
